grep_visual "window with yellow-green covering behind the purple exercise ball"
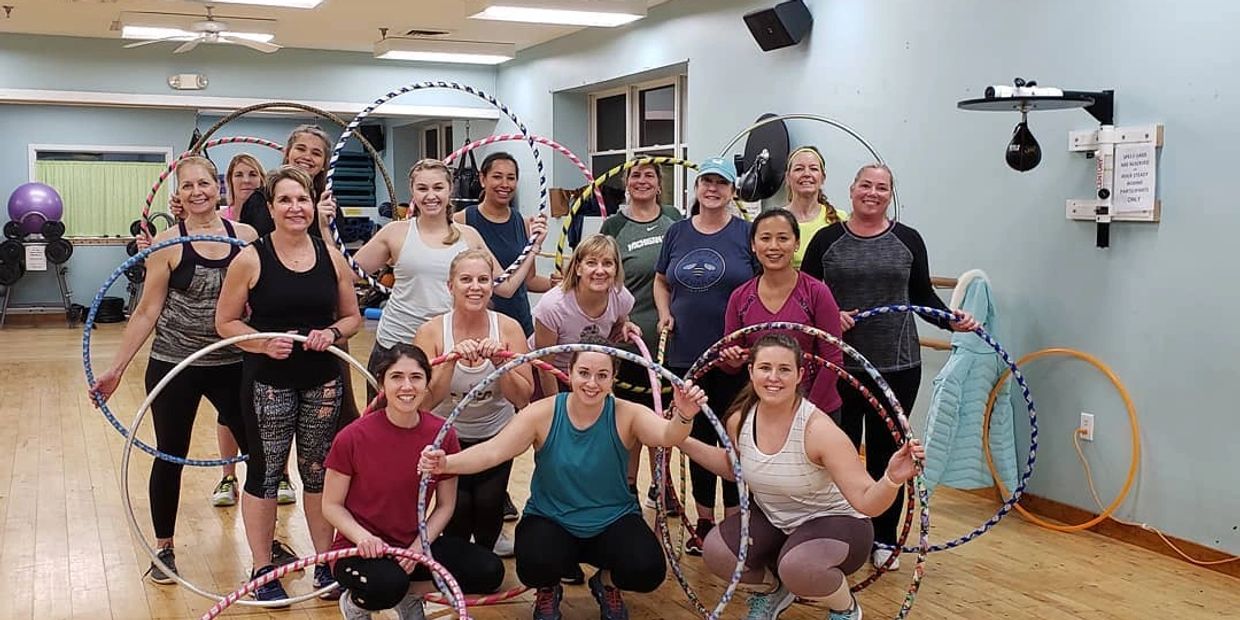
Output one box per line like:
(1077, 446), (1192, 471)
(29, 144), (174, 237)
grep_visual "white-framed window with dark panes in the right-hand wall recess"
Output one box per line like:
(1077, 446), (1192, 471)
(589, 76), (688, 210)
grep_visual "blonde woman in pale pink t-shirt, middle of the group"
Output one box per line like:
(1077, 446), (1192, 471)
(529, 234), (641, 396)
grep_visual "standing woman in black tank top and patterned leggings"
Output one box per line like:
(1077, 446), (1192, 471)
(216, 166), (362, 600)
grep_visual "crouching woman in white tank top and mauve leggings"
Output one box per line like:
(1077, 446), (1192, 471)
(682, 335), (925, 620)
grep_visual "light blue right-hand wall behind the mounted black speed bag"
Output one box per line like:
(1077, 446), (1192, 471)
(498, 0), (1240, 552)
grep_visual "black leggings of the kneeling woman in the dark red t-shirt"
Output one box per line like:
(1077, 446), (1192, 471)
(332, 534), (503, 611)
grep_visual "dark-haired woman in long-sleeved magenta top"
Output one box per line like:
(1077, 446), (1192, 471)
(720, 208), (843, 422)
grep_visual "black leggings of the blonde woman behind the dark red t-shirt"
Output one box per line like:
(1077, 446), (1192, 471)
(444, 438), (512, 549)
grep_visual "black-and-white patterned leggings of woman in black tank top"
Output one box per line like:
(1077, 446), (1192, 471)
(246, 377), (343, 500)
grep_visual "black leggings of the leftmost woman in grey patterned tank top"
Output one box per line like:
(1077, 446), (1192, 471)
(146, 360), (248, 538)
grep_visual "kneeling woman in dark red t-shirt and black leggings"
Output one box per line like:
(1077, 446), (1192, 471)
(322, 342), (503, 620)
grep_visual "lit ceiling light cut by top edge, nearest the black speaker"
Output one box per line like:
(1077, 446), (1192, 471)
(465, 0), (646, 27)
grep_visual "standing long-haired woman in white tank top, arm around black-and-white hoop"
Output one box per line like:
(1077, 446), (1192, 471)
(353, 159), (547, 398)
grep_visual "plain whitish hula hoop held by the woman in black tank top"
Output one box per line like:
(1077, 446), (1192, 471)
(120, 332), (376, 608)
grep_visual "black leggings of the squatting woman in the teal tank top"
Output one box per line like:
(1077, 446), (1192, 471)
(515, 513), (667, 591)
